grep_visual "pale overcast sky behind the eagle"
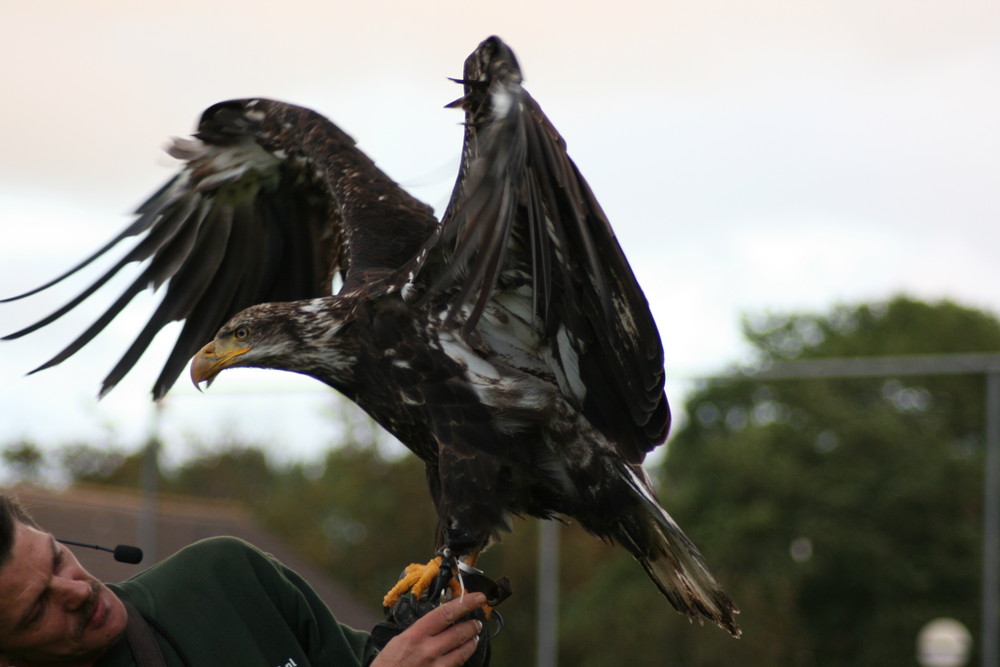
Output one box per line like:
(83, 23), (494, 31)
(0, 0), (1000, 470)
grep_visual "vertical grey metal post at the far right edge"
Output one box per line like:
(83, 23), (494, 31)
(982, 370), (1000, 667)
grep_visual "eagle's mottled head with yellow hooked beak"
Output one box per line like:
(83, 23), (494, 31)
(191, 296), (354, 388)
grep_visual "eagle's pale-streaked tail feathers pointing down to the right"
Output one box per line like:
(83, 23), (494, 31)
(620, 466), (741, 637)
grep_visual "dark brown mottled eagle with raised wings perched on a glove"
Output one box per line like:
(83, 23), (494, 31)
(7, 37), (740, 636)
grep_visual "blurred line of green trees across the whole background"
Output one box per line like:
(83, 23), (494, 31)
(3, 297), (1000, 667)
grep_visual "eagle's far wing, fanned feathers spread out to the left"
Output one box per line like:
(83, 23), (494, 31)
(6, 99), (437, 398)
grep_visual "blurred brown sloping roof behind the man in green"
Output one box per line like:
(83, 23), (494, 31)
(2, 484), (380, 630)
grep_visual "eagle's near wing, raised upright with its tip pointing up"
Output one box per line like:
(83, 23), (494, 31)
(421, 37), (670, 462)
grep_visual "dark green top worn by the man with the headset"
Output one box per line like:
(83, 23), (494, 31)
(97, 537), (376, 667)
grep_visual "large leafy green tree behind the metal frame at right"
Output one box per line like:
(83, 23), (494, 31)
(662, 298), (988, 665)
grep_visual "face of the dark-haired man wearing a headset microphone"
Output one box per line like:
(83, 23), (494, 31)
(0, 523), (128, 665)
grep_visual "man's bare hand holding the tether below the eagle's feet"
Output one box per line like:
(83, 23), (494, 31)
(371, 593), (486, 667)
